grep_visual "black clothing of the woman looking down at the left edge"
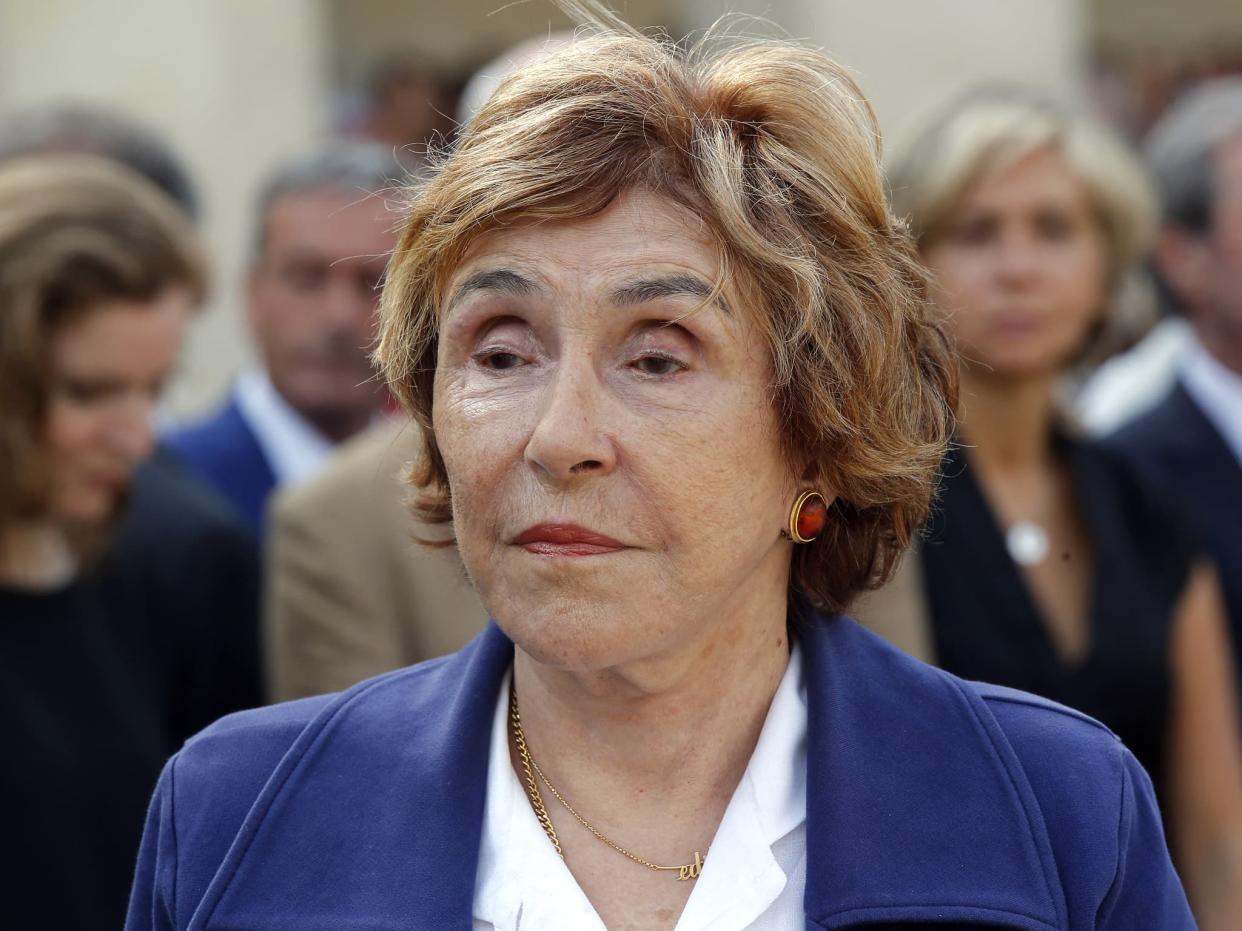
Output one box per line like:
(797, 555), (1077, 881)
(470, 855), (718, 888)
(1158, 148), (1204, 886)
(0, 458), (262, 931)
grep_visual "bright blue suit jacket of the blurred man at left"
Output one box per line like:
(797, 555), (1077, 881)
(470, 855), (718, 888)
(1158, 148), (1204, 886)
(164, 397), (276, 536)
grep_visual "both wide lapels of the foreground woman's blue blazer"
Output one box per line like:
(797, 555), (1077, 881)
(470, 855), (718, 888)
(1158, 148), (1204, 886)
(203, 618), (1066, 931)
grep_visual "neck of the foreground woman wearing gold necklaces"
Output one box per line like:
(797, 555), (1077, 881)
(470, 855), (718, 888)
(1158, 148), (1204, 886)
(514, 591), (789, 857)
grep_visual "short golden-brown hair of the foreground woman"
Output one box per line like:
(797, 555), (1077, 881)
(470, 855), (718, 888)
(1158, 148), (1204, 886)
(376, 14), (956, 611)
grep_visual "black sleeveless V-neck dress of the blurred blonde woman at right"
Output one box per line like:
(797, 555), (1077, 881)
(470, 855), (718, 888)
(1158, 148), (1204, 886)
(922, 434), (1196, 794)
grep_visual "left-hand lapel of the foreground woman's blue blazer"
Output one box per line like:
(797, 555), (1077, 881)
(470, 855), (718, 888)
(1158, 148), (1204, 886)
(190, 624), (513, 931)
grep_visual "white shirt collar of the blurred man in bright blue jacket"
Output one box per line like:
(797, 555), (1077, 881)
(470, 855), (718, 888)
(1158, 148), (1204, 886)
(233, 369), (333, 485)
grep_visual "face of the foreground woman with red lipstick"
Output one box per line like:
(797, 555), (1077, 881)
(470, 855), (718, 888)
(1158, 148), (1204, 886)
(432, 191), (795, 670)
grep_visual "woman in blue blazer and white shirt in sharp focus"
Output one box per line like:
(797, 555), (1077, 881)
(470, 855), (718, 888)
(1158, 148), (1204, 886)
(129, 18), (1191, 931)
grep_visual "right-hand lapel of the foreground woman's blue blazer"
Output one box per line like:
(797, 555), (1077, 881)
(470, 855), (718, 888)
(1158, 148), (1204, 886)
(804, 618), (1066, 931)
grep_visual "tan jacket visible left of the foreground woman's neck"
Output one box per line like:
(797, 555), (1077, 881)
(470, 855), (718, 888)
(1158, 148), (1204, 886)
(265, 420), (487, 701)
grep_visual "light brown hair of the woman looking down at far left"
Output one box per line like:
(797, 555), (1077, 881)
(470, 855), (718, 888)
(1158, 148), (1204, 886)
(0, 155), (206, 530)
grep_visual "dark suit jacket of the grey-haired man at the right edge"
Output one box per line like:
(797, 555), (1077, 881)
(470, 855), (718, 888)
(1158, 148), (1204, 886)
(1105, 384), (1242, 669)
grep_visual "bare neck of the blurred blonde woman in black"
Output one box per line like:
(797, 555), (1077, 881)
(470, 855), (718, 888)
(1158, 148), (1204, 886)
(959, 369), (1056, 470)
